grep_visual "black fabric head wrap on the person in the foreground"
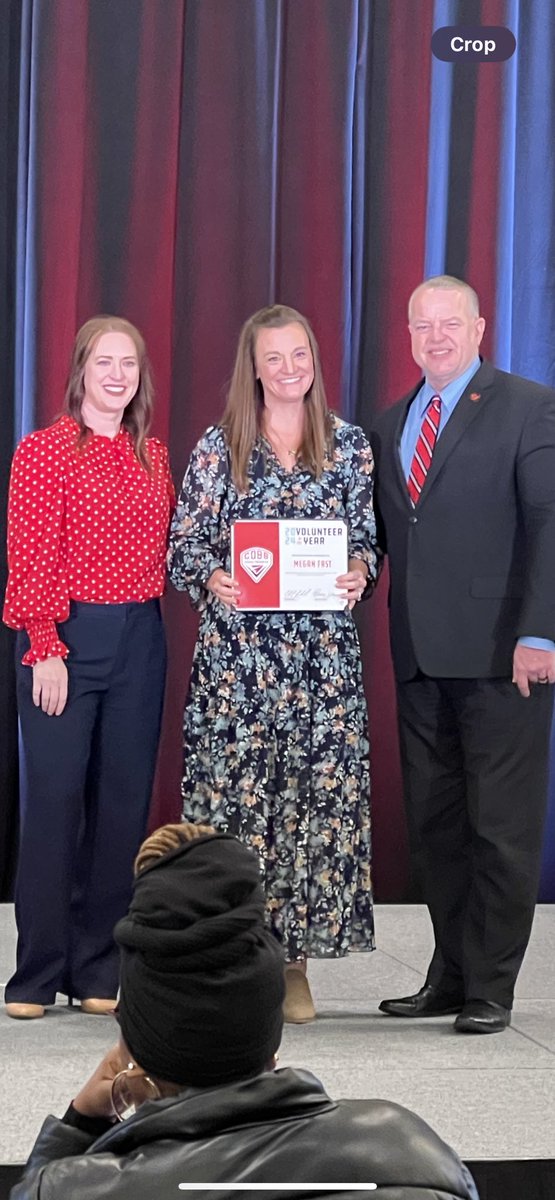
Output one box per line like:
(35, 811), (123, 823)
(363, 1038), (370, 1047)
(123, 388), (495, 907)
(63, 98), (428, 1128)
(114, 834), (285, 1087)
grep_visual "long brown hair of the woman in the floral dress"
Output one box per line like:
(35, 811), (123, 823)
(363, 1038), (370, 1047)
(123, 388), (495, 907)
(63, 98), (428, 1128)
(220, 304), (333, 492)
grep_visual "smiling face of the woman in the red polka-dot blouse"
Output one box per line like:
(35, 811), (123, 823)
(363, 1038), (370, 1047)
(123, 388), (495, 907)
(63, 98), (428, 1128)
(83, 330), (141, 415)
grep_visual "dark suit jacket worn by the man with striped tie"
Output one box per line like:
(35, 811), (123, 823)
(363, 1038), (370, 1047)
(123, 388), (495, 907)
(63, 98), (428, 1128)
(371, 362), (555, 680)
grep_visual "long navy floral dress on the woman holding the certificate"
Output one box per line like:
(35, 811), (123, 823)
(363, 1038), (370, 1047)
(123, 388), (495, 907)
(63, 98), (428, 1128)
(168, 416), (377, 961)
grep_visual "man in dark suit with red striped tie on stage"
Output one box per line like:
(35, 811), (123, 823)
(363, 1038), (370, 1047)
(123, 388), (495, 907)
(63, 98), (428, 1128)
(371, 276), (555, 1033)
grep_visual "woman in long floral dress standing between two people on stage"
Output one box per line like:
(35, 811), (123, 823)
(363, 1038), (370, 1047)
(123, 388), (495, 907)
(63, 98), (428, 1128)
(169, 305), (378, 1021)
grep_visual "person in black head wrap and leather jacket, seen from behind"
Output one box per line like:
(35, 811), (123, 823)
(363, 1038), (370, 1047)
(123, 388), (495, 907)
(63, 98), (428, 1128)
(11, 824), (478, 1200)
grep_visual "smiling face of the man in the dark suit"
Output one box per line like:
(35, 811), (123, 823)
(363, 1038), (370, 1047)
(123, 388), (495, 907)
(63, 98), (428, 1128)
(408, 288), (485, 391)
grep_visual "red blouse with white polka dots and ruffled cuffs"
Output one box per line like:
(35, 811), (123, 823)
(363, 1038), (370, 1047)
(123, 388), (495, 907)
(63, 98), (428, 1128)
(4, 416), (175, 666)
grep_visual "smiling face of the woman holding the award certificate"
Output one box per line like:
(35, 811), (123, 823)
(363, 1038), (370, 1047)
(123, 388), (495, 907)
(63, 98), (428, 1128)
(255, 322), (314, 404)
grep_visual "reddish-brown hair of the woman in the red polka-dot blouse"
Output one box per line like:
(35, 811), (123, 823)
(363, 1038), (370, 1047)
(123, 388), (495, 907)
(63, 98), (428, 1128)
(64, 316), (154, 470)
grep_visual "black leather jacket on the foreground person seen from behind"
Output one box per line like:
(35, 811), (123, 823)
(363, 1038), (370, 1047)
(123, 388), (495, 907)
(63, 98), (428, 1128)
(12, 1069), (478, 1200)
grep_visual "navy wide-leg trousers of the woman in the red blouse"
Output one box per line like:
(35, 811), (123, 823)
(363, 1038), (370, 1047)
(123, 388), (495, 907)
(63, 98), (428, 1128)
(5, 600), (166, 1004)
